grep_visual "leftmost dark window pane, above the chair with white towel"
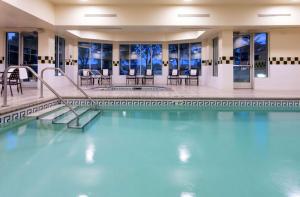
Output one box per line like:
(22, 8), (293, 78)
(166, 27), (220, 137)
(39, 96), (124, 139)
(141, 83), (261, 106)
(6, 32), (20, 65)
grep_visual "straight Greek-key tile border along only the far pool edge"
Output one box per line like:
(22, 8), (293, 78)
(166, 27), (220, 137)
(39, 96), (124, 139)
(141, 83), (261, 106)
(66, 98), (300, 110)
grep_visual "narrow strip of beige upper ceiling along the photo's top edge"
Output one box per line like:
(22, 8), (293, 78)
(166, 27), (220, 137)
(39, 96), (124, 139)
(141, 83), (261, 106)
(48, 0), (300, 5)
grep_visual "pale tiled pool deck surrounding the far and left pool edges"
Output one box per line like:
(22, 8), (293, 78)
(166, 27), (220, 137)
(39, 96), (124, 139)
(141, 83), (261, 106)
(0, 86), (300, 114)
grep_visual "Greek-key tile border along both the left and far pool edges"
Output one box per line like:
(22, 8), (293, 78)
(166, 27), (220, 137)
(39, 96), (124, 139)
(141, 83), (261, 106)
(0, 98), (300, 126)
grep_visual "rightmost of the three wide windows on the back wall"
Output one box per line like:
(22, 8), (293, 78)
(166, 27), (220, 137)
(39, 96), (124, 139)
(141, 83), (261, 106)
(169, 43), (201, 75)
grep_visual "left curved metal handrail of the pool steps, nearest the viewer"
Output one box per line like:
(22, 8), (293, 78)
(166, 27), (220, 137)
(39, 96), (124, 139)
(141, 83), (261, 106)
(2, 66), (79, 125)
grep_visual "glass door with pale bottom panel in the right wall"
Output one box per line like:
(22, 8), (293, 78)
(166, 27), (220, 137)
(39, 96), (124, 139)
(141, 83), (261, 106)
(233, 34), (253, 88)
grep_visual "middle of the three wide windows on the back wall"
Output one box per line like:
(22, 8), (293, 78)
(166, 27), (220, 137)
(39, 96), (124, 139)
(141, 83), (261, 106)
(120, 44), (162, 75)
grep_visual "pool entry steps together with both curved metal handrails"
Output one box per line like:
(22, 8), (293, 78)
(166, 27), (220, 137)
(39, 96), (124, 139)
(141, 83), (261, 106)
(3, 65), (100, 129)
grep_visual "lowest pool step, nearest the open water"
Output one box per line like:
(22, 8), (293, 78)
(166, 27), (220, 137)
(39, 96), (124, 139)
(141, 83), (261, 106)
(68, 109), (101, 129)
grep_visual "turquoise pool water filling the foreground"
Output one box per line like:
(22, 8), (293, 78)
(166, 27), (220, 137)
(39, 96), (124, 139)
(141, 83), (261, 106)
(0, 109), (300, 197)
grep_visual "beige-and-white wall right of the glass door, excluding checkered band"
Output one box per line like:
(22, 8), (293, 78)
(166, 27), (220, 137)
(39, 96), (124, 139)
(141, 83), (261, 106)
(254, 29), (300, 90)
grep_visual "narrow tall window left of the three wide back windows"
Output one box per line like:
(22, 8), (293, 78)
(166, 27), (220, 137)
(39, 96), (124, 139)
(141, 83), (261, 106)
(55, 36), (65, 75)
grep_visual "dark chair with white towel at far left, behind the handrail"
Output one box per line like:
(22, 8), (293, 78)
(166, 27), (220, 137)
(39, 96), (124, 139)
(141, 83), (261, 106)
(0, 68), (23, 96)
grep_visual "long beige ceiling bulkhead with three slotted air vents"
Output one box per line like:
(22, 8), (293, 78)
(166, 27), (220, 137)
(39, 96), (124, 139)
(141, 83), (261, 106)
(55, 5), (300, 27)
